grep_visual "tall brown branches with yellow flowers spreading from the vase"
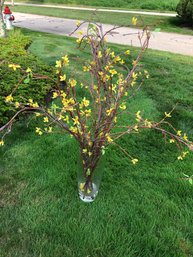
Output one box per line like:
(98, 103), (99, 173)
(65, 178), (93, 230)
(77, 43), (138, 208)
(0, 20), (193, 176)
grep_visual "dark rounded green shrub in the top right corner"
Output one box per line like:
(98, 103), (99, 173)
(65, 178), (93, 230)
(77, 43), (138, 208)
(177, 0), (193, 25)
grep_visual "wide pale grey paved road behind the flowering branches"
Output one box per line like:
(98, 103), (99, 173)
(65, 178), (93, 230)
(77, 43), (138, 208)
(14, 13), (193, 56)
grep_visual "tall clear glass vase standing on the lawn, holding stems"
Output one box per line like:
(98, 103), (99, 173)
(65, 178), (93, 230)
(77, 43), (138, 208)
(78, 152), (104, 203)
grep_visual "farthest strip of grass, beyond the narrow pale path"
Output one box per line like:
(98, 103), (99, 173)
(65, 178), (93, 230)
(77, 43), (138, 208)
(13, 0), (179, 11)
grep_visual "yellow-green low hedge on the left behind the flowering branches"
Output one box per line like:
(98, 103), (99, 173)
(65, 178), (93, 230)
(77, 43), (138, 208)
(0, 31), (53, 124)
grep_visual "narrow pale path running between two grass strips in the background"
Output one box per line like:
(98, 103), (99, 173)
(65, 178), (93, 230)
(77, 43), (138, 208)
(5, 2), (177, 17)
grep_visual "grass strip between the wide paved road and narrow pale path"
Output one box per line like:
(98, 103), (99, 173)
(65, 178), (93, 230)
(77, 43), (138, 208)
(12, 6), (193, 35)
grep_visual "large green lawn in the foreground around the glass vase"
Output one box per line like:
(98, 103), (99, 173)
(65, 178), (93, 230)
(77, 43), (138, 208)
(0, 31), (193, 257)
